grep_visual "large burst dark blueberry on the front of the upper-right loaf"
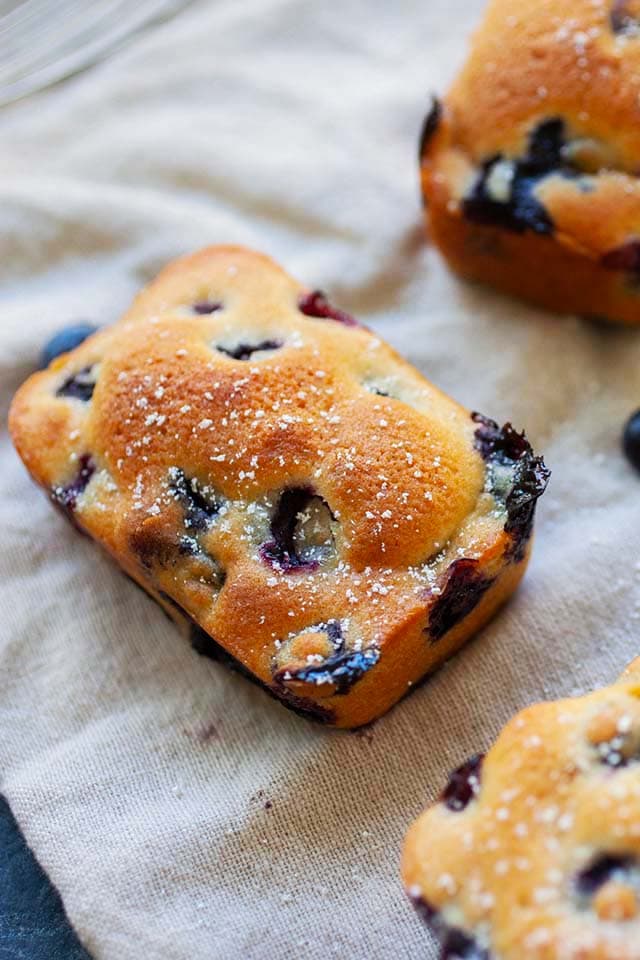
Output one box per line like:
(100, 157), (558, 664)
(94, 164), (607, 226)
(462, 117), (577, 235)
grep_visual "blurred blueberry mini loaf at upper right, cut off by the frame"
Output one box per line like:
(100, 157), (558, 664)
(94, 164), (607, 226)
(420, 0), (640, 324)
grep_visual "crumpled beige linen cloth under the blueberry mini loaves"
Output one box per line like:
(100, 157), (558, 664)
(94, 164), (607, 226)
(0, 0), (640, 960)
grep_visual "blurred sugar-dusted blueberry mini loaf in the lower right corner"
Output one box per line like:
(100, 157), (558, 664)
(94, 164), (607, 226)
(402, 659), (640, 960)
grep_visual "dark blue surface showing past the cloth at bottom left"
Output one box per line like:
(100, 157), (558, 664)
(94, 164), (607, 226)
(0, 797), (91, 960)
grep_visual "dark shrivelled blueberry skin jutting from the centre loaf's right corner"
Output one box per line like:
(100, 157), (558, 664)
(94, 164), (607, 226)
(471, 413), (551, 563)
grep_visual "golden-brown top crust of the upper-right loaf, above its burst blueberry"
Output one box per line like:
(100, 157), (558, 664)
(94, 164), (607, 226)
(447, 0), (640, 169)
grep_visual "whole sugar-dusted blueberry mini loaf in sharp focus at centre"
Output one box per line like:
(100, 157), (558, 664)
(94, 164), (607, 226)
(10, 247), (547, 727)
